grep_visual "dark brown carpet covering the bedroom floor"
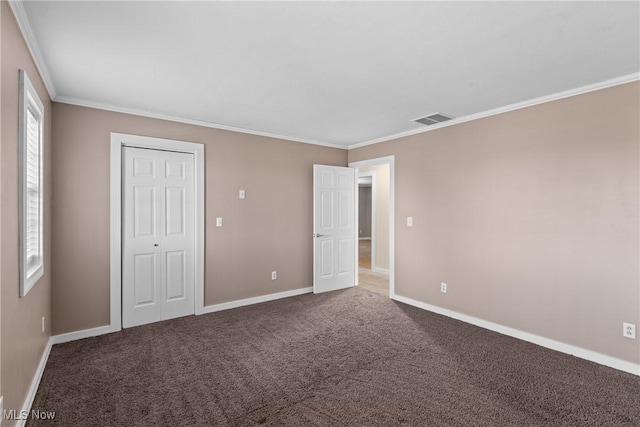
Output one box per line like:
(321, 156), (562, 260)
(28, 289), (640, 427)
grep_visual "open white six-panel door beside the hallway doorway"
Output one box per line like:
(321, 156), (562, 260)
(313, 165), (356, 293)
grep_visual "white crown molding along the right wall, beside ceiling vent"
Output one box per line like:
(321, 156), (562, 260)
(347, 73), (640, 150)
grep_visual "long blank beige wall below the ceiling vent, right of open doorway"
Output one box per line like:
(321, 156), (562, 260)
(349, 82), (640, 363)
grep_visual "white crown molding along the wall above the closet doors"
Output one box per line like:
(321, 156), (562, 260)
(53, 96), (347, 150)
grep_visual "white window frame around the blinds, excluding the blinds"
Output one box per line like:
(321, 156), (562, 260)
(18, 70), (45, 297)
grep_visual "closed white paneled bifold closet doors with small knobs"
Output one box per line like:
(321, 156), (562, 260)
(122, 147), (195, 328)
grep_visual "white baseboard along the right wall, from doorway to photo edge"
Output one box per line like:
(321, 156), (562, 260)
(390, 294), (640, 376)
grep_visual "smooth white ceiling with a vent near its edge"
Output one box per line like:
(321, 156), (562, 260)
(14, 1), (640, 146)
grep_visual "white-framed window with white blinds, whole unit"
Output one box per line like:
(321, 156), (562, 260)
(19, 70), (44, 296)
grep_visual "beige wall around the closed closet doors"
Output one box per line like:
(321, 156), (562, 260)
(52, 103), (347, 334)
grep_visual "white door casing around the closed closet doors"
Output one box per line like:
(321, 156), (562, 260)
(109, 132), (205, 332)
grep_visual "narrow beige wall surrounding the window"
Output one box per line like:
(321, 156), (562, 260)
(0, 2), (52, 418)
